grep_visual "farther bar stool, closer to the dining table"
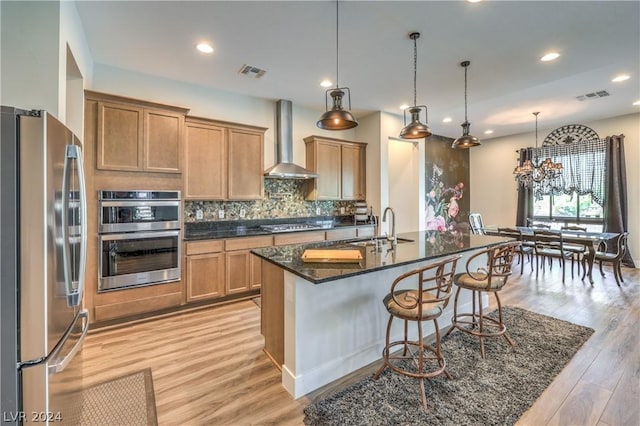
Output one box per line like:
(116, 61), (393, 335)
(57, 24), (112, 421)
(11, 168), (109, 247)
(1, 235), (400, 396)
(445, 241), (521, 358)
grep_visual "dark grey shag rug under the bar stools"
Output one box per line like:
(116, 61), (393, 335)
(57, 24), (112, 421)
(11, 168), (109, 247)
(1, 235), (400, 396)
(304, 307), (594, 426)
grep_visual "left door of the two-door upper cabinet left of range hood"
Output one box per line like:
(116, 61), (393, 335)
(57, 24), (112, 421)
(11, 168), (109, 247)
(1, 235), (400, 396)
(184, 118), (227, 200)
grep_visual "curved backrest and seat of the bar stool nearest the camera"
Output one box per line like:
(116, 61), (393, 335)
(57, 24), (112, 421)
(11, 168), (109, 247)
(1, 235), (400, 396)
(384, 255), (462, 318)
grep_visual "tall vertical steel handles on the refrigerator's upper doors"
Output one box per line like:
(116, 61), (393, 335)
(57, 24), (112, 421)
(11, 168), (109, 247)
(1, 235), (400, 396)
(62, 145), (87, 306)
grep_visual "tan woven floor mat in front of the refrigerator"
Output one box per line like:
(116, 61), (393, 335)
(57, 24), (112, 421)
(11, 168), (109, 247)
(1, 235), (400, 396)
(63, 368), (158, 426)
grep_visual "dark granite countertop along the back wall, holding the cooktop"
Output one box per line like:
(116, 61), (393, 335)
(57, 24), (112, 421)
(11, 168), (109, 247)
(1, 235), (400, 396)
(184, 216), (372, 241)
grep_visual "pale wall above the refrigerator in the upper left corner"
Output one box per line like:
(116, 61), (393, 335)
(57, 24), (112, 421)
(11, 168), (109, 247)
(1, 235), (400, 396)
(0, 1), (93, 131)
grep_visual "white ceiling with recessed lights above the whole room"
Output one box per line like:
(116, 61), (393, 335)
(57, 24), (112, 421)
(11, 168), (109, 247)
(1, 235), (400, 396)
(76, 0), (640, 139)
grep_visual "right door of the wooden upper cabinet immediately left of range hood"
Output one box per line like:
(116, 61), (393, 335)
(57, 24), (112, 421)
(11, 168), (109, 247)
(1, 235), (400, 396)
(227, 128), (264, 200)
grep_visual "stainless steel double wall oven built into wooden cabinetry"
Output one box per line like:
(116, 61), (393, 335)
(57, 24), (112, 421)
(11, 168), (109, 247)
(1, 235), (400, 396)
(98, 190), (181, 292)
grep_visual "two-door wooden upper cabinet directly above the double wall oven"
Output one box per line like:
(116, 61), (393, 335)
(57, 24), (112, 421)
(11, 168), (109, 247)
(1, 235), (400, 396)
(85, 91), (188, 173)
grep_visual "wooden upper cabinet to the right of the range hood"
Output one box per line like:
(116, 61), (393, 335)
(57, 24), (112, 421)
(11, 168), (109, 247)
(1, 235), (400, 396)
(304, 136), (367, 200)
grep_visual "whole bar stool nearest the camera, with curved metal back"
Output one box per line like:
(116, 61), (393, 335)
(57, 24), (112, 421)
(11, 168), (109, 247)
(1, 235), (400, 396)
(373, 256), (461, 411)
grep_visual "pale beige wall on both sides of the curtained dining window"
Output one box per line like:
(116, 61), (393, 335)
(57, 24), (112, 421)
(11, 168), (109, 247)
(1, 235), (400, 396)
(470, 113), (640, 265)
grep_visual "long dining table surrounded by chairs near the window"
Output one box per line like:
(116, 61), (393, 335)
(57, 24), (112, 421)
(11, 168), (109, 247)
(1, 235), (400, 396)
(482, 226), (620, 285)
